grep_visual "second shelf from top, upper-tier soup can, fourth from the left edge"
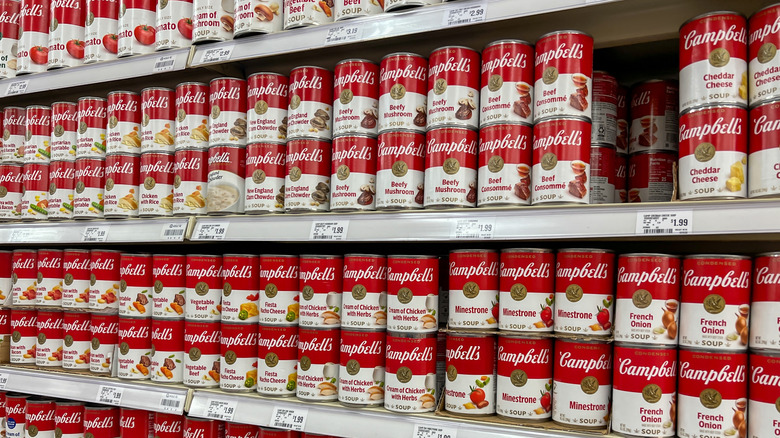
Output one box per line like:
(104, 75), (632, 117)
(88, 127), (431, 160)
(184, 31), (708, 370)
(76, 96), (107, 159)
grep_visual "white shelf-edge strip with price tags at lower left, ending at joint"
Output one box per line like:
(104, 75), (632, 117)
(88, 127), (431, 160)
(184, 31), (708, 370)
(0, 365), (190, 414)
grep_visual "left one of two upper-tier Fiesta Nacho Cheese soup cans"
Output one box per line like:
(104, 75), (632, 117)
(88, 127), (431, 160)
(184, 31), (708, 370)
(222, 254), (260, 324)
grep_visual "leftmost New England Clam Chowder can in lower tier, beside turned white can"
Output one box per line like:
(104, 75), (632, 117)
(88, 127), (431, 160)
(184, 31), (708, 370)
(244, 143), (287, 214)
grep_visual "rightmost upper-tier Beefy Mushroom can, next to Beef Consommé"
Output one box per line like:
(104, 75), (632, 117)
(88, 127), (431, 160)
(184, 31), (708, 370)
(427, 46), (480, 131)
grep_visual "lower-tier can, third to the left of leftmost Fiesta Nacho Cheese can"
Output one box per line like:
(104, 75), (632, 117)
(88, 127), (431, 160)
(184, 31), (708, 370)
(116, 317), (152, 380)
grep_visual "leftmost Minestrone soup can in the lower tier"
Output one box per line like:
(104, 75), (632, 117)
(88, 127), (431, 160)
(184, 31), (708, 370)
(444, 333), (496, 415)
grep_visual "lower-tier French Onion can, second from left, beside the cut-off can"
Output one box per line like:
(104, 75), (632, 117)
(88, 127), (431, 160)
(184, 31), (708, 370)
(676, 349), (748, 438)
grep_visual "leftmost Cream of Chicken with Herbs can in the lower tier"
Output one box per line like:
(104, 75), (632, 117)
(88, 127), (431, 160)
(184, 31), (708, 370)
(296, 327), (341, 401)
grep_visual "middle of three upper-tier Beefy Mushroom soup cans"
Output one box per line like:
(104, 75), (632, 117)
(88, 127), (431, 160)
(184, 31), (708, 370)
(377, 52), (428, 134)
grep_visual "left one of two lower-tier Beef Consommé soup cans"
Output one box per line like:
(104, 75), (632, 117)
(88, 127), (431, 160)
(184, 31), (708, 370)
(477, 124), (533, 207)
